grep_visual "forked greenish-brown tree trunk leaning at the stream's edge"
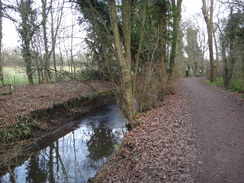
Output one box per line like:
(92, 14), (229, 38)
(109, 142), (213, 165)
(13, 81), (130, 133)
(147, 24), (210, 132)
(108, 0), (135, 127)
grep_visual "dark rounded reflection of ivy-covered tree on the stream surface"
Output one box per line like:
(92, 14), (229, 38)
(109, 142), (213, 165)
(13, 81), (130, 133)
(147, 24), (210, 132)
(86, 121), (116, 162)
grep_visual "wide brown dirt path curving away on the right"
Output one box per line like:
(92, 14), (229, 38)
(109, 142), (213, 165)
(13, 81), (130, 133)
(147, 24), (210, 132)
(181, 78), (244, 183)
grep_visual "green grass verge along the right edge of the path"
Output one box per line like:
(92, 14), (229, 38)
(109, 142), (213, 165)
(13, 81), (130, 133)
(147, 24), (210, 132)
(206, 77), (244, 93)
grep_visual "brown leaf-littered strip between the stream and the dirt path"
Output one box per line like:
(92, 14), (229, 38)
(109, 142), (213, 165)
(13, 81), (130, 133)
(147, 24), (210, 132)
(90, 83), (196, 183)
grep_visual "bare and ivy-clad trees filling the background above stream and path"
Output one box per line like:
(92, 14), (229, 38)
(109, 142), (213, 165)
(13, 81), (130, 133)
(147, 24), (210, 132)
(0, 0), (244, 123)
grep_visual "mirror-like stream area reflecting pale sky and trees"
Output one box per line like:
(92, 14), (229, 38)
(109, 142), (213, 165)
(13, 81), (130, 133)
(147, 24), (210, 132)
(1, 115), (123, 183)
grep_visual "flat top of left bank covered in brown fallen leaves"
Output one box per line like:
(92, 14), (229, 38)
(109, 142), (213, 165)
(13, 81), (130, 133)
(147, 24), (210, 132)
(0, 81), (113, 128)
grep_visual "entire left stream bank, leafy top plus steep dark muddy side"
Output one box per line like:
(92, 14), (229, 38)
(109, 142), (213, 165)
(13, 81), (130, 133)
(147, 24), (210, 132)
(0, 81), (115, 174)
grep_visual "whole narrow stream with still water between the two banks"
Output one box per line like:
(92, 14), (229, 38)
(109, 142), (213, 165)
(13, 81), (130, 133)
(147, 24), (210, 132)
(0, 105), (127, 183)
